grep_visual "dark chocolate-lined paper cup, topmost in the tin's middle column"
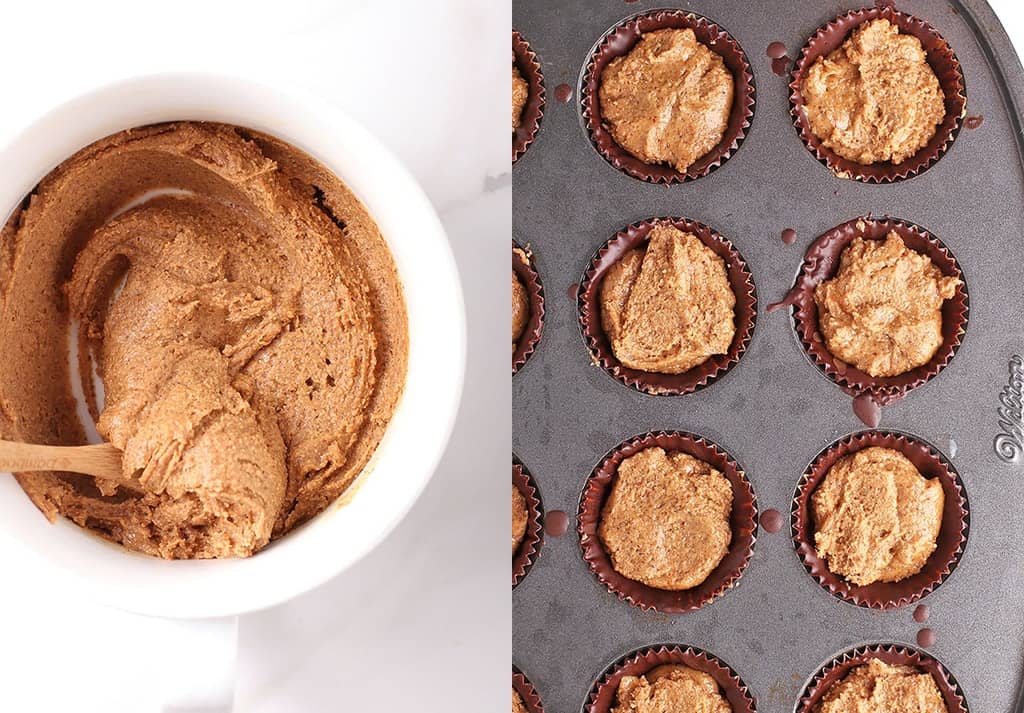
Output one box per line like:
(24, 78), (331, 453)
(580, 10), (755, 184)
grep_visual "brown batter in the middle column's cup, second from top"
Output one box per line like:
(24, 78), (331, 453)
(600, 225), (736, 374)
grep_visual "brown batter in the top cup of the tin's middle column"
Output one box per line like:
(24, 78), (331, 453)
(598, 29), (733, 172)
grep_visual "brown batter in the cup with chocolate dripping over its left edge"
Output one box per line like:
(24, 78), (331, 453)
(814, 233), (959, 376)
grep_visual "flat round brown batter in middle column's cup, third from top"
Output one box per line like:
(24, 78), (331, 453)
(598, 447), (732, 590)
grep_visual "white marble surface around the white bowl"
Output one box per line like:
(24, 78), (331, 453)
(0, 0), (511, 713)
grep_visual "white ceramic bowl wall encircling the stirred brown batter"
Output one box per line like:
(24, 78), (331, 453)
(0, 74), (465, 618)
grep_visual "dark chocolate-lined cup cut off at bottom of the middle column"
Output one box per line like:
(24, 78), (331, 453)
(584, 643), (757, 713)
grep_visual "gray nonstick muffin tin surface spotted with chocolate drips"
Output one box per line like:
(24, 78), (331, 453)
(512, 0), (1024, 713)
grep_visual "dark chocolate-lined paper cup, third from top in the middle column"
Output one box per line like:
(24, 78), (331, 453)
(578, 431), (758, 614)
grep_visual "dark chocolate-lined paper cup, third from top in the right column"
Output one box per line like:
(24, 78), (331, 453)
(792, 430), (971, 610)
